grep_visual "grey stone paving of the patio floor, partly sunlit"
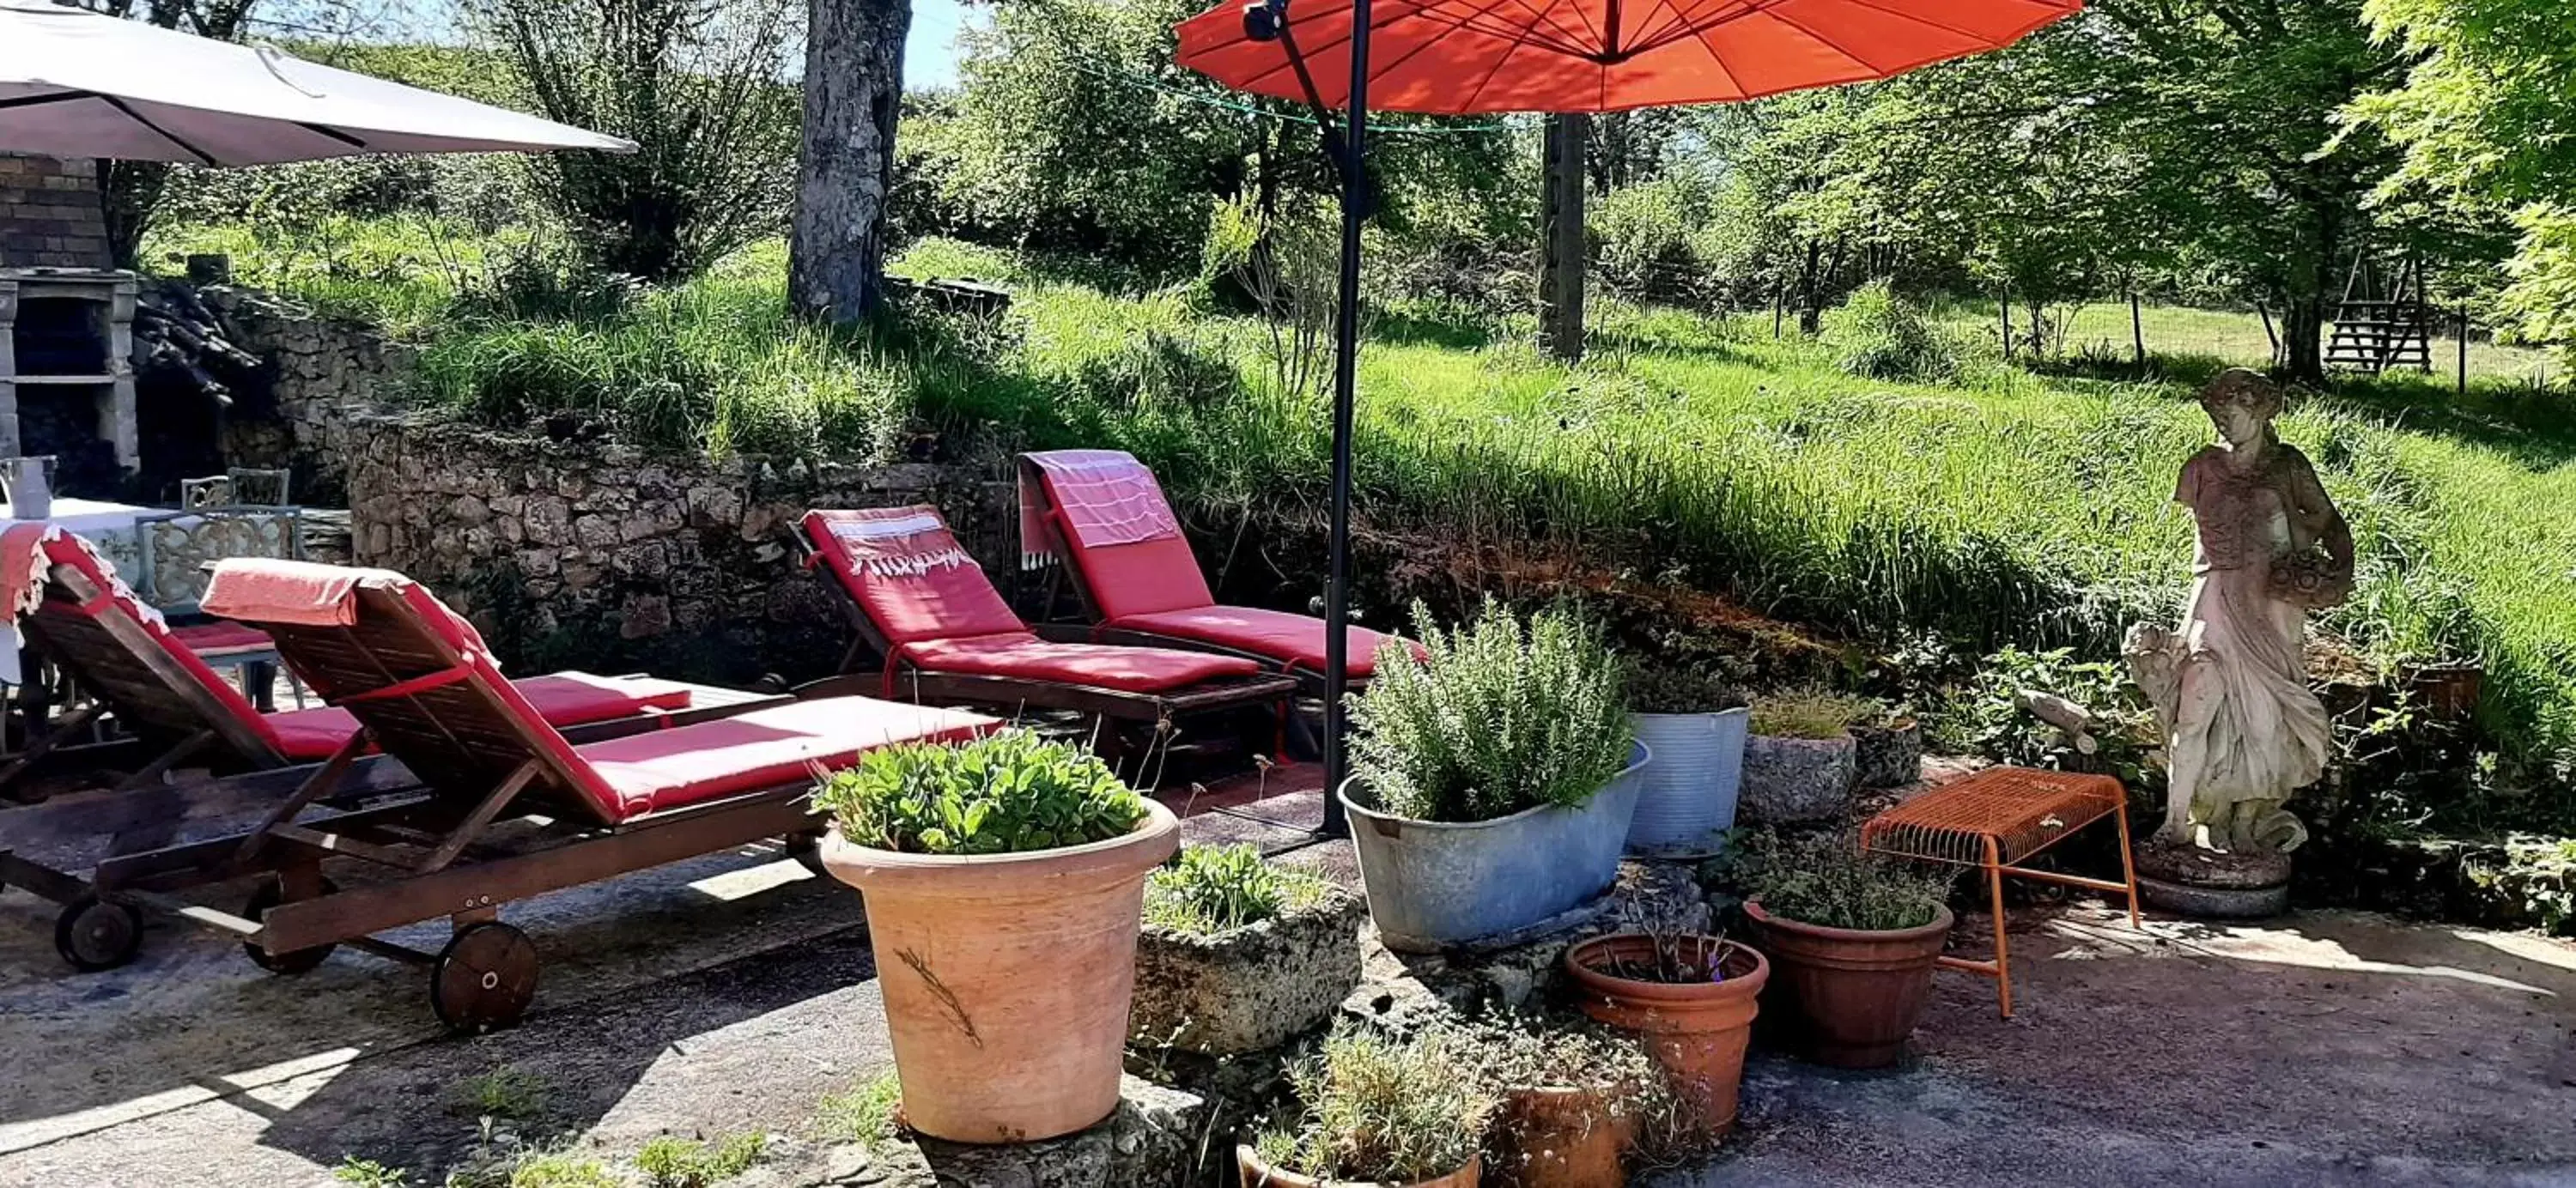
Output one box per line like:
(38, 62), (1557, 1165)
(0, 768), (2576, 1188)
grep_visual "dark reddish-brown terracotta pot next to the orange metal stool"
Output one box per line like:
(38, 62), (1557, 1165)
(1744, 900), (1950, 1070)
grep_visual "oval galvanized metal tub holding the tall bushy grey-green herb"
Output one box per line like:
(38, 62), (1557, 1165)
(1342, 742), (1654, 954)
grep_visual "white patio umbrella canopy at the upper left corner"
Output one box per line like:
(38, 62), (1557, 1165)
(0, 0), (634, 165)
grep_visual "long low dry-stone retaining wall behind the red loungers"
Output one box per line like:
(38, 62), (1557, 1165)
(343, 415), (1018, 683)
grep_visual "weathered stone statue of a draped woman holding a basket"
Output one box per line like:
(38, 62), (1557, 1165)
(2128, 368), (2352, 861)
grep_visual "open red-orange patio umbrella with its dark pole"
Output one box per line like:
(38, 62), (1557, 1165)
(1180, 0), (2084, 833)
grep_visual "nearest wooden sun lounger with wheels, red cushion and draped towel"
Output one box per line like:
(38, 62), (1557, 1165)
(98, 559), (994, 1031)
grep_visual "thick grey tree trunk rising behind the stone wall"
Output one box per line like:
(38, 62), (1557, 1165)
(788, 0), (912, 322)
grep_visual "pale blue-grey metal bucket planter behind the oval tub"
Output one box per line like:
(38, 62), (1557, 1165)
(1628, 665), (1752, 856)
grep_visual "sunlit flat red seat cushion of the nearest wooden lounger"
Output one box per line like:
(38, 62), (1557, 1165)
(572, 699), (994, 820)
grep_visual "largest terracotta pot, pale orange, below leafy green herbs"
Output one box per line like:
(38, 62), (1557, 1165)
(822, 802), (1180, 1142)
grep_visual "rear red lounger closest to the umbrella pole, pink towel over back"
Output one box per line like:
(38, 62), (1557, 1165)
(1020, 448), (1391, 694)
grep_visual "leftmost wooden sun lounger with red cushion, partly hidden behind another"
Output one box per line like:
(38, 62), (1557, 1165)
(0, 533), (788, 969)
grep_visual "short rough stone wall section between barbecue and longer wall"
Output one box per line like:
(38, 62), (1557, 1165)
(198, 286), (417, 505)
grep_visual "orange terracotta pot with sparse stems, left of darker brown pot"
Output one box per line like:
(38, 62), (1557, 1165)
(1566, 933), (1770, 1134)
